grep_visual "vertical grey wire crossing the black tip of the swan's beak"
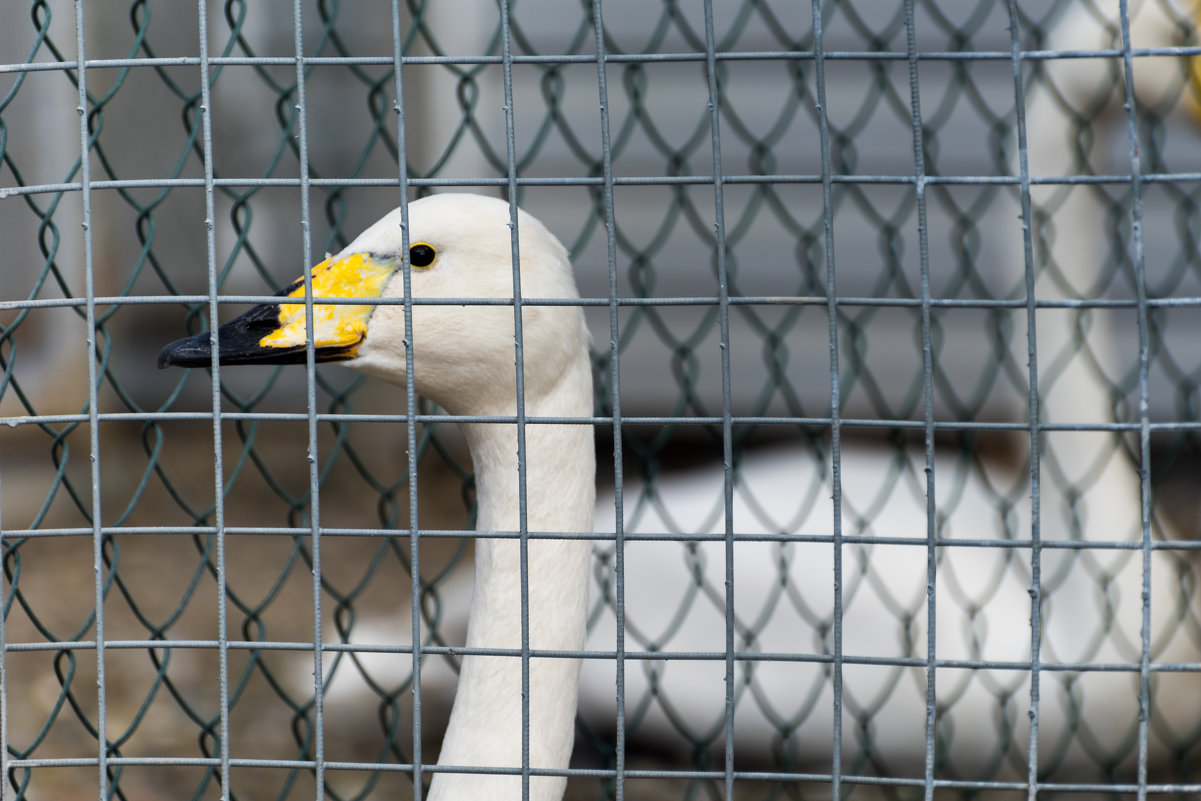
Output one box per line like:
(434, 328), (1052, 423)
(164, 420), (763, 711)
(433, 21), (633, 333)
(196, 0), (231, 801)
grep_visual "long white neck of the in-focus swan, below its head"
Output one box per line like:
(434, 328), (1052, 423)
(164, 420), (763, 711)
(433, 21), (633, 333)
(430, 357), (596, 801)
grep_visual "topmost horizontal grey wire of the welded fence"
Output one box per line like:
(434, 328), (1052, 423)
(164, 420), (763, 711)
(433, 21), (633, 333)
(0, 46), (1201, 74)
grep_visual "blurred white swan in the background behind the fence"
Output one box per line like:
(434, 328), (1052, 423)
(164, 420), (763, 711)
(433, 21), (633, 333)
(297, 2), (1201, 778)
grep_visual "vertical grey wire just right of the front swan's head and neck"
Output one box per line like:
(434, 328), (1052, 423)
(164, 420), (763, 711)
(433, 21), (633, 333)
(592, 0), (626, 801)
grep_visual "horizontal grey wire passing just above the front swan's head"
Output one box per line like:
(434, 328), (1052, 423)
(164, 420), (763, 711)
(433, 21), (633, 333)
(7, 172), (1201, 201)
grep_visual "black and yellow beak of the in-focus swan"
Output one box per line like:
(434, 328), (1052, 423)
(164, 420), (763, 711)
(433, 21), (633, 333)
(159, 253), (400, 369)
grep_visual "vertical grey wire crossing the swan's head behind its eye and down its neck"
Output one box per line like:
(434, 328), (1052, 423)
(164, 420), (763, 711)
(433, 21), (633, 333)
(500, 0), (530, 800)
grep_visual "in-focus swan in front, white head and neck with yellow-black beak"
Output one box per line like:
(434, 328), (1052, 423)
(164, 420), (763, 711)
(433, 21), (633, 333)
(159, 195), (596, 801)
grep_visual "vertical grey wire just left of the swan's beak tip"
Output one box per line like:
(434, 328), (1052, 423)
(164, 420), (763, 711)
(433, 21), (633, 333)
(76, 0), (108, 801)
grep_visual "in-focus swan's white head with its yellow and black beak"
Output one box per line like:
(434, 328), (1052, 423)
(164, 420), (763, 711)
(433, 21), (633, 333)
(159, 195), (587, 414)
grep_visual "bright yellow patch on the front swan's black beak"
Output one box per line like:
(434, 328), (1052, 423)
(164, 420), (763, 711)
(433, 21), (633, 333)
(258, 253), (398, 355)
